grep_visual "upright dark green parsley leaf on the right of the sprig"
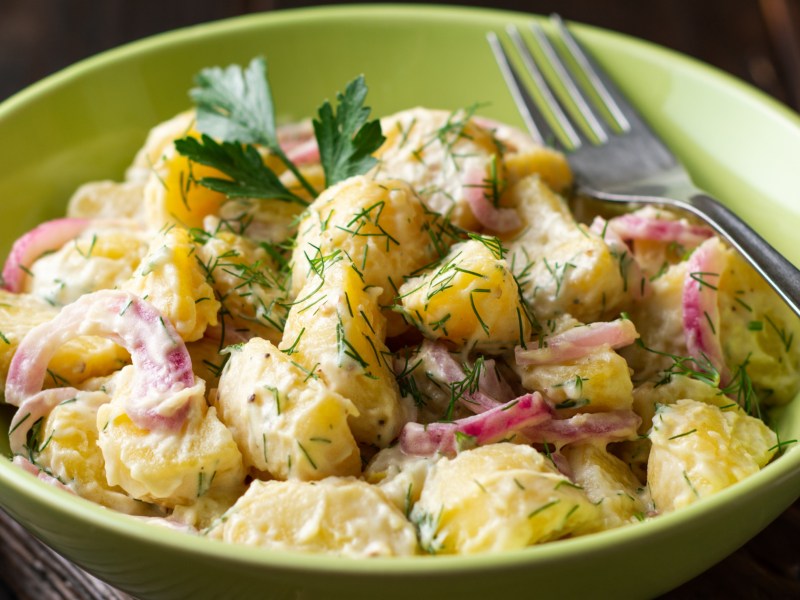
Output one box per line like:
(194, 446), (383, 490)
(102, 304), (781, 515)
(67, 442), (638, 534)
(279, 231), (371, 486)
(314, 75), (386, 187)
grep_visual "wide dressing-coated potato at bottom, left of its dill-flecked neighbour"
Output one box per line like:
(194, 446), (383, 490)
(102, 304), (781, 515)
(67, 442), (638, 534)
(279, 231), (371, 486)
(208, 477), (417, 558)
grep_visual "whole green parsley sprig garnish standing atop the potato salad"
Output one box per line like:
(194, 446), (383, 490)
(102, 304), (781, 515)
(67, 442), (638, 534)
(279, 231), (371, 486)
(175, 57), (385, 205)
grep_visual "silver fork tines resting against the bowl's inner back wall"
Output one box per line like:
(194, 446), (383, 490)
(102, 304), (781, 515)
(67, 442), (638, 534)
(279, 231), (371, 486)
(487, 15), (640, 150)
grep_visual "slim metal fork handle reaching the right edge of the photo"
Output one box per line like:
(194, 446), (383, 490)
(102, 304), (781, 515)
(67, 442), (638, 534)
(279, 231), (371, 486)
(686, 194), (800, 317)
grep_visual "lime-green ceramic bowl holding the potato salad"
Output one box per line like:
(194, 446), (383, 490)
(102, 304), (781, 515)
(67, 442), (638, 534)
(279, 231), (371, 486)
(0, 6), (800, 600)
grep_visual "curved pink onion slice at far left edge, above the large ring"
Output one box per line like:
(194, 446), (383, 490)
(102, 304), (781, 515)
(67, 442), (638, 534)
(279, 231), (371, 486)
(3, 217), (91, 293)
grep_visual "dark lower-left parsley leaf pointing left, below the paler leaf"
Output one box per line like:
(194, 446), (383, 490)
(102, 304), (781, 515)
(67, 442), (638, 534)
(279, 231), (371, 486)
(175, 133), (308, 206)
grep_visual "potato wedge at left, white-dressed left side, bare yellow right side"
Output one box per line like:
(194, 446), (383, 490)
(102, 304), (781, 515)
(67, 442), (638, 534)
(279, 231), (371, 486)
(122, 226), (220, 342)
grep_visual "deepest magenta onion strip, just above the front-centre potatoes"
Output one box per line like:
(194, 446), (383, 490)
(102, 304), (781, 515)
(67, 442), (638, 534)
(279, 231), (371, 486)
(400, 392), (552, 456)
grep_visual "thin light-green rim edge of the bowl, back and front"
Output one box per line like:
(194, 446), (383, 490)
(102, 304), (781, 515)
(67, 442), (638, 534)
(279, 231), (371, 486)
(0, 4), (800, 576)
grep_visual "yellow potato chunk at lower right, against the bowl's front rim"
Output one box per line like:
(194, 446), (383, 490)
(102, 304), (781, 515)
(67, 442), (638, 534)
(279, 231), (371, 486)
(647, 399), (778, 513)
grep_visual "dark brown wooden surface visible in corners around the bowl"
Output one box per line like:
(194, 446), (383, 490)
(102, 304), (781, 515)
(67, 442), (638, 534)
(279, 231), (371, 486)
(0, 0), (800, 600)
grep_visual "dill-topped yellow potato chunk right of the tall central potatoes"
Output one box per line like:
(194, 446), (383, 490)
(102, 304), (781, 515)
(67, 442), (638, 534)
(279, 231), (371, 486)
(400, 238), (531, 353)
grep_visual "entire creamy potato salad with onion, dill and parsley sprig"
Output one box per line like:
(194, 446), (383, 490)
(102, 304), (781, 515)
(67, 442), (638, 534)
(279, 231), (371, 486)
(0, 59), (800, 557)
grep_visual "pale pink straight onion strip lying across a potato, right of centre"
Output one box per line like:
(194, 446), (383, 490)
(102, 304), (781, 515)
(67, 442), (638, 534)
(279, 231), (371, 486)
(514, 319), (639, 365)
